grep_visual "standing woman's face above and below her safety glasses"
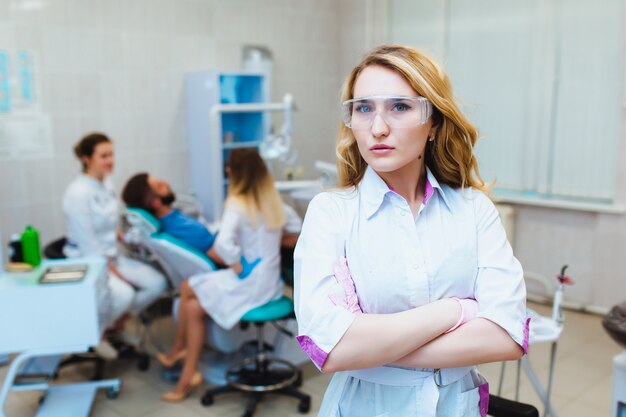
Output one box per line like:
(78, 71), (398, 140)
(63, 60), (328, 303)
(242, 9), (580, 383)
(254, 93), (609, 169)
(353, 65), (434, 174)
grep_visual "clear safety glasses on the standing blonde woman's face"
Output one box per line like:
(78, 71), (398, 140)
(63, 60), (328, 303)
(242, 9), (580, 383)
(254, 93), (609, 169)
(341, 96), (433, 130)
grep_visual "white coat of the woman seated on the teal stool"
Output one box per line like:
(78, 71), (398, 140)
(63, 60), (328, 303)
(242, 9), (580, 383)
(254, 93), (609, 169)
(189, 205), (302, 330)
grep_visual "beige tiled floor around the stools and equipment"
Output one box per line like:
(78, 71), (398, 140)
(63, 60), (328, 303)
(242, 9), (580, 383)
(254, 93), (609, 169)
(0, 305), (621, 417)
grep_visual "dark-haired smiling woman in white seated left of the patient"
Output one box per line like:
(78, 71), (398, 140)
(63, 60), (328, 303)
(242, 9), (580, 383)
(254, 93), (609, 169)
(63, 133), (167, 324)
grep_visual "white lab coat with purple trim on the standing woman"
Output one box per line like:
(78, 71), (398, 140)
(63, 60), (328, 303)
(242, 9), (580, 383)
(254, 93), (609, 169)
(294, 168), (528, 417)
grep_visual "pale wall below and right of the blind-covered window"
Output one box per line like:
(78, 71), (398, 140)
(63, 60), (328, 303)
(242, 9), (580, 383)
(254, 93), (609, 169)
(514, 110), (626, 308)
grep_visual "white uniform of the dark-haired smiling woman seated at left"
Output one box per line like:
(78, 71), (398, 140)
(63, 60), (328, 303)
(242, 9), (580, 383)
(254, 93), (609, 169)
(63, 174), (167, 323)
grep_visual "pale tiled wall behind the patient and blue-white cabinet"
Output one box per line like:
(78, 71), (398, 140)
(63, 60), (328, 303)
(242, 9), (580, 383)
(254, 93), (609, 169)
(0, 0), (340, 244)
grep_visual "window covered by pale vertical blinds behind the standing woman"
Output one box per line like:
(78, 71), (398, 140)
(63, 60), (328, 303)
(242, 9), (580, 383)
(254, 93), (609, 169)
(388, 0), (624, 203)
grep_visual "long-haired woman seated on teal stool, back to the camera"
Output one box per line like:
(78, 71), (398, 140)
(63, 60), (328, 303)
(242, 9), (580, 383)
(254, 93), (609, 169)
(157, 149), (301, 401)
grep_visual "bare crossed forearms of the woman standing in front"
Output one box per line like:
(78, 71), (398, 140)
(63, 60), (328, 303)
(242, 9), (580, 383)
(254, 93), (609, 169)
(322, 298), (522, 372)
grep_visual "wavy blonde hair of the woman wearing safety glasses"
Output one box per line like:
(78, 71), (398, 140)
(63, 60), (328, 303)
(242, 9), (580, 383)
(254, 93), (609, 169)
(336, 45), (487, 191)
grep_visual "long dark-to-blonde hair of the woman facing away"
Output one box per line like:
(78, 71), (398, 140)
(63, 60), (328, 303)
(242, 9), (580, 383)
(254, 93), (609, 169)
(225, 148), (285, 230)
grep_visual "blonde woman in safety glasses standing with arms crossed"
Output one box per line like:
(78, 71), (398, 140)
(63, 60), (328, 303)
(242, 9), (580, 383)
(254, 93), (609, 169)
(294, 45), (528, 417)
